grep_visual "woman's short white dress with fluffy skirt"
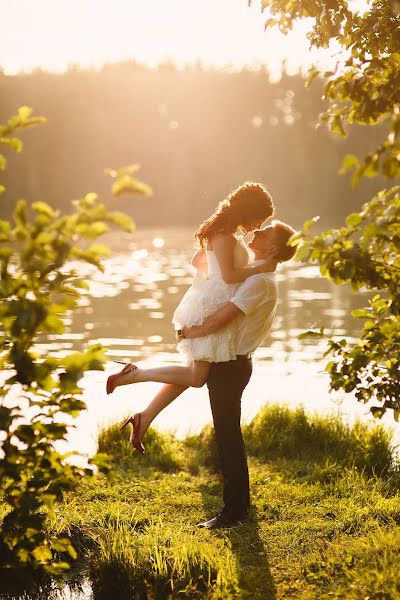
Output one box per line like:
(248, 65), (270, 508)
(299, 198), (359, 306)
(172, 238), (249, 362)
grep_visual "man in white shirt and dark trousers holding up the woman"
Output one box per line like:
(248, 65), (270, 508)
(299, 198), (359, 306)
(113, 221), (295, 529)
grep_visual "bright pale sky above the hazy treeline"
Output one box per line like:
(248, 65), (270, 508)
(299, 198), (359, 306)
(0, 0), (340, 76)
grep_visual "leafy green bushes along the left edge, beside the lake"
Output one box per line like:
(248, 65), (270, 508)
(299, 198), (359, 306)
(0, 107), (150, 574)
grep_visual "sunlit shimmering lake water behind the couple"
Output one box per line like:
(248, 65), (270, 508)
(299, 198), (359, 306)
(31, 229), (400, 454)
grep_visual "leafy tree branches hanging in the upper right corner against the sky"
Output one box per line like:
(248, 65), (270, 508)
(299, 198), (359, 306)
(262, 0), (400, 184)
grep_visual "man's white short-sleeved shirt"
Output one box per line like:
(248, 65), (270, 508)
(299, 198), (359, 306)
(230, 263), (278, 355)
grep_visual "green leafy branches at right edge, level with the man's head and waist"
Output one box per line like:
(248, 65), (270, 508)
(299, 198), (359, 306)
(294, 187), (400, 420)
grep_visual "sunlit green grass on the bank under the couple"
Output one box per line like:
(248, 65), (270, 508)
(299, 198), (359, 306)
(0, 406), (400, 600)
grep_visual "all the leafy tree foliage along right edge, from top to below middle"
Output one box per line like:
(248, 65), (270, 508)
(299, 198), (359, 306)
(262, 0), (400, 420)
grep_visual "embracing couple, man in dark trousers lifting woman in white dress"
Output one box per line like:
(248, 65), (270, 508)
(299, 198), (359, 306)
(107, 182), (295, 529)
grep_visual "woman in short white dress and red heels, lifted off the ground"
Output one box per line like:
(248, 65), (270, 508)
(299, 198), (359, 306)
(107, 182), (274, 453)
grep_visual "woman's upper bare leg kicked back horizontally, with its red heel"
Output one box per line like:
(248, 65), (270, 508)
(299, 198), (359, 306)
(107, 360), (210, 393)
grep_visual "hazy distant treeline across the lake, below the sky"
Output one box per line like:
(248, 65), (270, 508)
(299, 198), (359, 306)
(0, 62), (388, 227)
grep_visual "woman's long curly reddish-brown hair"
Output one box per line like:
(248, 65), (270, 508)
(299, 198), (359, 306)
(194, 181), (274, 249)
